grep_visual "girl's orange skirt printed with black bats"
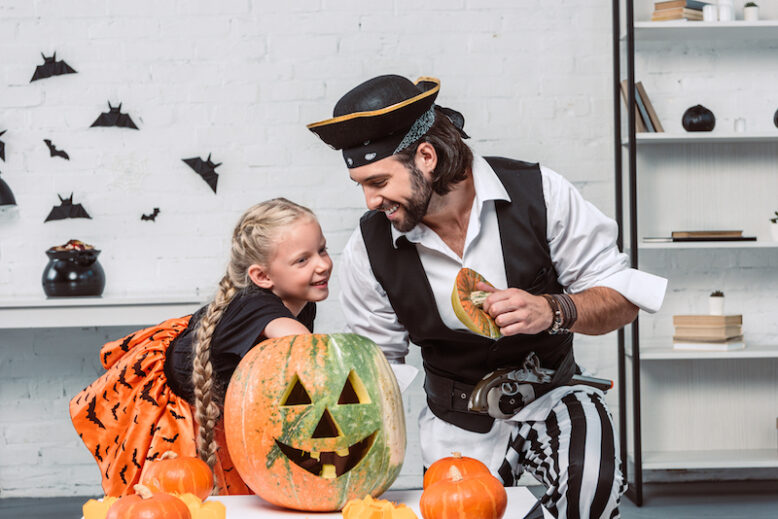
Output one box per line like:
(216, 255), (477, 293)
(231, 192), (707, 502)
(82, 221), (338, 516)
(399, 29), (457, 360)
(70, 316), (251, 496)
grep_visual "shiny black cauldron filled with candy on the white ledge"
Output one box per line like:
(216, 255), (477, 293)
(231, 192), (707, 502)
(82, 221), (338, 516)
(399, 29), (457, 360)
(41, 249), (105, 297)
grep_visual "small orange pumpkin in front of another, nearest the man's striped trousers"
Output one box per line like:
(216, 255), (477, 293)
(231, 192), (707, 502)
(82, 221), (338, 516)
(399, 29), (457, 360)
(419, 466), (508, 519)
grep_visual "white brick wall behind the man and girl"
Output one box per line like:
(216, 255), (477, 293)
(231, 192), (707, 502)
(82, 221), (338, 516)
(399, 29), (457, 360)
(0, 0), (775, 497)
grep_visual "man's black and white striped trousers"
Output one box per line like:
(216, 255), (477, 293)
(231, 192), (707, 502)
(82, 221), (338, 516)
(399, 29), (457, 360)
(499, 391), (626, 519)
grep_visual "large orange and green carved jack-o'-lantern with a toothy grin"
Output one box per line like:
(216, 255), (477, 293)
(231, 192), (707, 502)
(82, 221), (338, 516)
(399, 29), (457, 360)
(224, 334), (405, 511)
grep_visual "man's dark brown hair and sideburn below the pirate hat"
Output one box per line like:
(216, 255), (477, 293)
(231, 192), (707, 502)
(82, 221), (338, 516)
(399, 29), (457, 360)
(394, 108), (473, 195)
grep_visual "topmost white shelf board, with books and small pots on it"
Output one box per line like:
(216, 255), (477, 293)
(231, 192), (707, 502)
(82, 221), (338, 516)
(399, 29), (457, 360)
(621, 20), (778, 42)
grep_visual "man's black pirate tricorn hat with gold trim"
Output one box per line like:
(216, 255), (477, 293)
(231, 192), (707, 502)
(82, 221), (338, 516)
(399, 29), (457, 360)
(308, 75), (440, 168)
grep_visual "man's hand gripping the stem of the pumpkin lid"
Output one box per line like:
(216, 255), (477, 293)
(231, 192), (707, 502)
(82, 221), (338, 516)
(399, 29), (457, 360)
(476, 283), (554, 335)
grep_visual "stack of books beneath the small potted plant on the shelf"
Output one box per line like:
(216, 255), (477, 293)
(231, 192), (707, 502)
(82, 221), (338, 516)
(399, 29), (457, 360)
(673, 315), (746, 351)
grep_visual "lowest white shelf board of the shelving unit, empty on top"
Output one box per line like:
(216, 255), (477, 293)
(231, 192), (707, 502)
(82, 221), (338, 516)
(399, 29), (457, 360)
(630, 448), (778, 470)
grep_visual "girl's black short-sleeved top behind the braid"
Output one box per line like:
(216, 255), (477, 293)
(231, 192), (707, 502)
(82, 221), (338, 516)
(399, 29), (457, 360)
(165, 286), (316, 403)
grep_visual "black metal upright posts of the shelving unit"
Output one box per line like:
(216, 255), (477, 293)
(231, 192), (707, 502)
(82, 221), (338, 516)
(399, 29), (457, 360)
(611, 0), (643, 506)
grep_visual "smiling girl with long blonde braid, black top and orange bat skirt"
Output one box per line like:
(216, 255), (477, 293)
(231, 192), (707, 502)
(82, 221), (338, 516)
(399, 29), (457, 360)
(70, 198), (332, 496)
